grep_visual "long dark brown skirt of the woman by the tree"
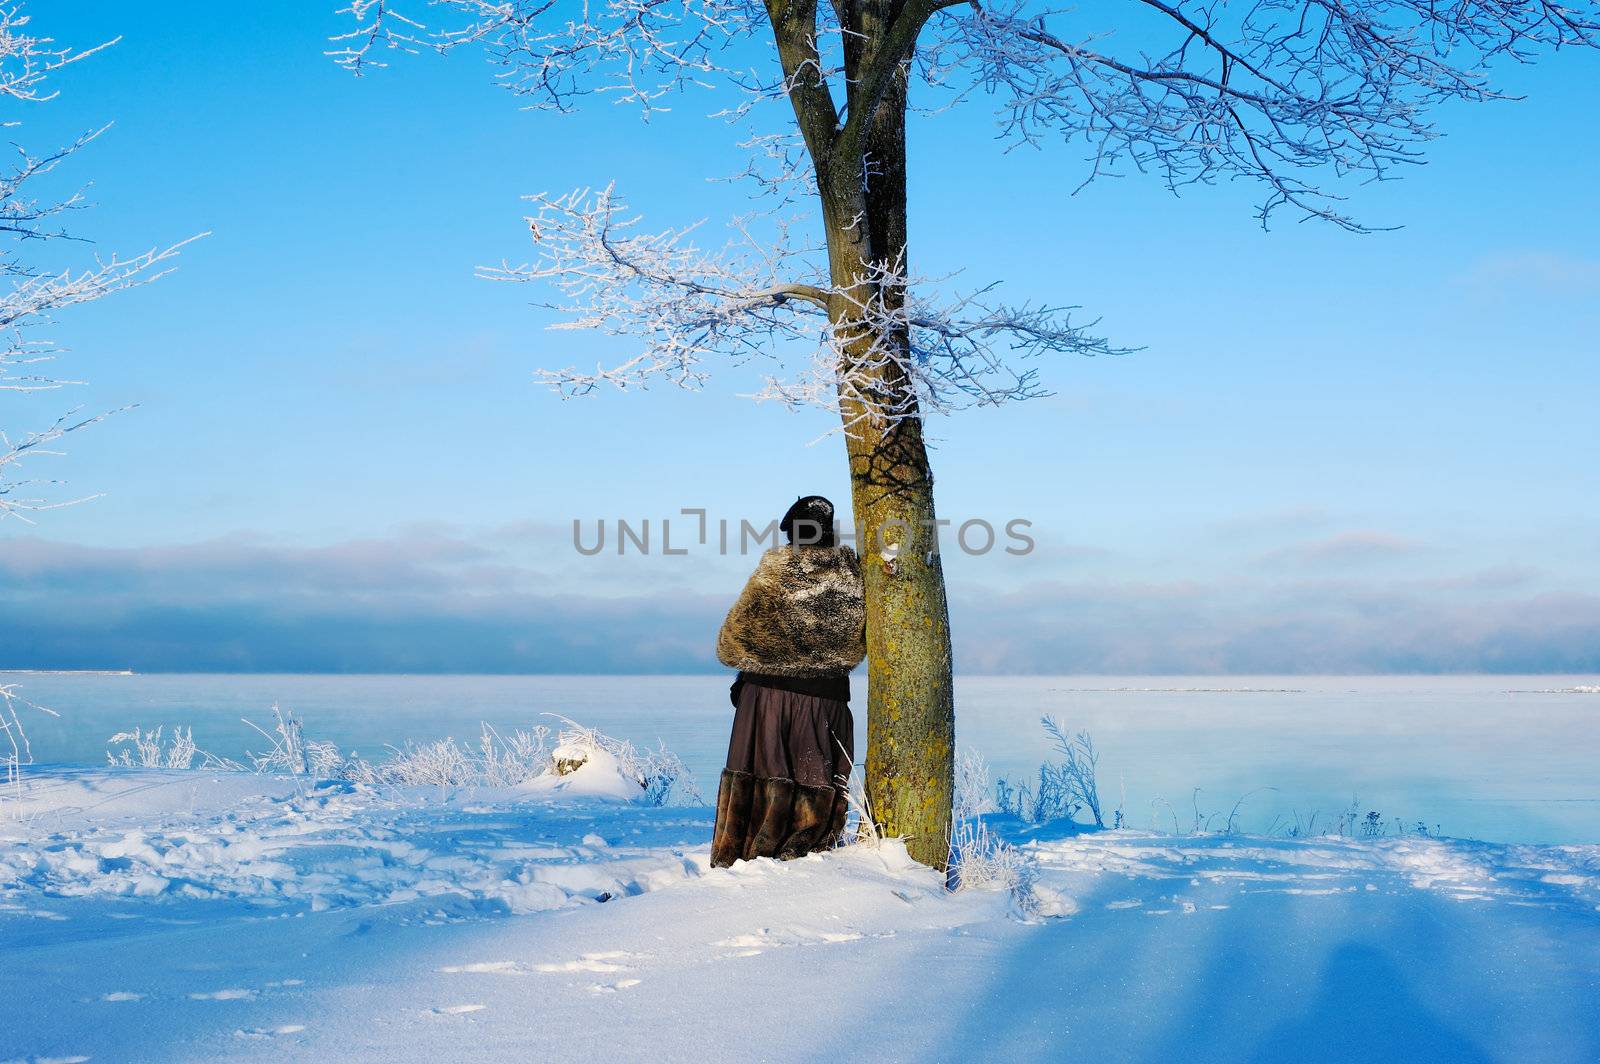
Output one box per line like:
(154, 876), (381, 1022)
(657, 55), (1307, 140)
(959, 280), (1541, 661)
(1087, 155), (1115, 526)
(710, 683), (856, 867)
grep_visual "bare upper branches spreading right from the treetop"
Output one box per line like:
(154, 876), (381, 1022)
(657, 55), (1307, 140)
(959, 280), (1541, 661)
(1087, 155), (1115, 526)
(922, 0), (1600, 230)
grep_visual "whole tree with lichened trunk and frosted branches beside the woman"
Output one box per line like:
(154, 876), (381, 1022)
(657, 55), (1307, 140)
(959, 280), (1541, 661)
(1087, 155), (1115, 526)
(331, 0), (1600, 867)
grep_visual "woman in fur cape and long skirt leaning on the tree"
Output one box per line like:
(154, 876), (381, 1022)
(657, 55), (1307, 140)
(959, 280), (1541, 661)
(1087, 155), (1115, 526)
(710, 494), (867, 867)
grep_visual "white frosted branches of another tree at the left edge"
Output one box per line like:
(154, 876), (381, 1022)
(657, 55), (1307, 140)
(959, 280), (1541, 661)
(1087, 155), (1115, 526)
(0, 5), (189, 522)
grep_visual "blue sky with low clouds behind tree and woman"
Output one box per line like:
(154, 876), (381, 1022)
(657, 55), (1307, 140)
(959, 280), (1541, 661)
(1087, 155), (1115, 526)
(0, 2), (1600, 672)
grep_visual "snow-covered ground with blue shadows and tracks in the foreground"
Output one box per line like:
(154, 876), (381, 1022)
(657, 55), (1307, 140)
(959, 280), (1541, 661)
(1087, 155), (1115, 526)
(0, 770), (1600, 1064)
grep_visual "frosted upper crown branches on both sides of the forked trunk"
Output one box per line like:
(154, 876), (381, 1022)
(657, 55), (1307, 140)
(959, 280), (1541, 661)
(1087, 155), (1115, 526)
(330, 0), (1600, 229)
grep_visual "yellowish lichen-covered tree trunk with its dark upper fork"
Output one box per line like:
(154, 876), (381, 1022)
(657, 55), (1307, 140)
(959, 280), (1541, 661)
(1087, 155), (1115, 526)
(766, 0), (955, 869)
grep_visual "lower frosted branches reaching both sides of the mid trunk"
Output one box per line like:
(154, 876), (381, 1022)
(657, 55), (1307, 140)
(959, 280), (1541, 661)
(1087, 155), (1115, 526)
(482, 187), (1114, 427)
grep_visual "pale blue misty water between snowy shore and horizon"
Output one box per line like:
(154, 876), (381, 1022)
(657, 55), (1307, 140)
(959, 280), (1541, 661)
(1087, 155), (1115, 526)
(0, 674), (1600, 843)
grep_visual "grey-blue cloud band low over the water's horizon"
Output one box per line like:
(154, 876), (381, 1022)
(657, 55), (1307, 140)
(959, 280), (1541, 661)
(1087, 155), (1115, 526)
(0, 533), (1600, 675)
